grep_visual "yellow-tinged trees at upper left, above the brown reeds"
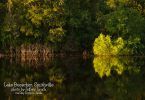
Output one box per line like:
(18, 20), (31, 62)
(0, 0), (65, 51)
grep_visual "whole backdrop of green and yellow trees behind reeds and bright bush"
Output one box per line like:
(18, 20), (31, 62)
(0, 0), (145, 54)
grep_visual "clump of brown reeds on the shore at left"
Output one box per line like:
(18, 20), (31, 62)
(9, 43), (53, 58)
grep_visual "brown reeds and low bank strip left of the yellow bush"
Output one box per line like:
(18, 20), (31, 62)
(0, 44), (92, 58)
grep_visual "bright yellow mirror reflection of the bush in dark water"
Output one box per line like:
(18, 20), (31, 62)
(93, 57), (124, 78)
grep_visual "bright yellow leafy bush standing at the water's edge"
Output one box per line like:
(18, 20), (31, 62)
(93, 33), (125, 55)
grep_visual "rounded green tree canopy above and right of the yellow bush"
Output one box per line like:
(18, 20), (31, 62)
(105, 9), (145, 38)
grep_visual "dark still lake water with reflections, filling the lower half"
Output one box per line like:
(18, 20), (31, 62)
(0, 57), (145, 100)
